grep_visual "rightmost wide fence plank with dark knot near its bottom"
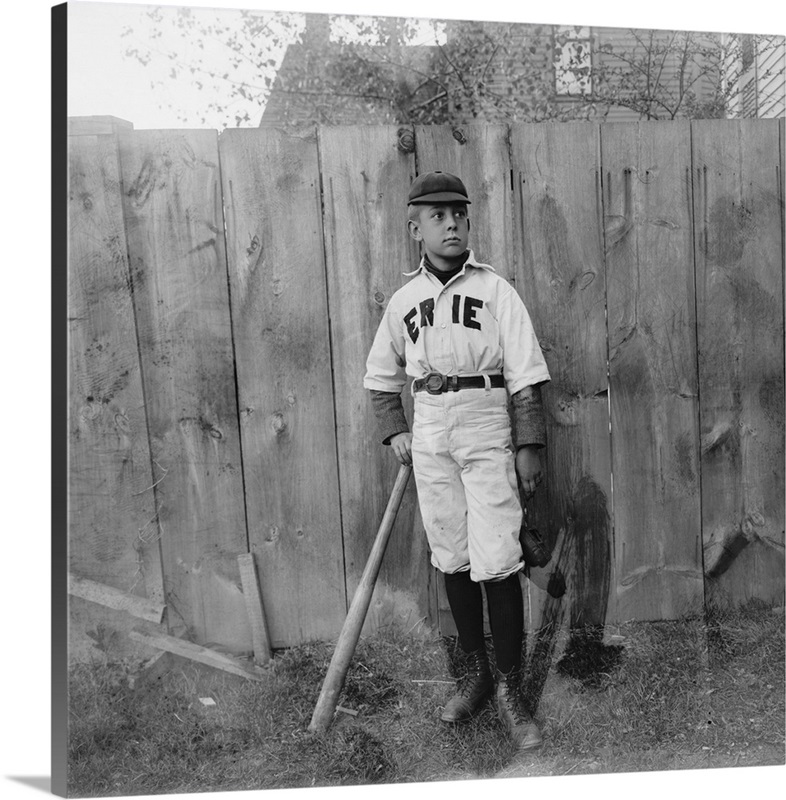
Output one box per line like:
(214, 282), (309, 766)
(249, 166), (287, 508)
(692, 120), (784, 604)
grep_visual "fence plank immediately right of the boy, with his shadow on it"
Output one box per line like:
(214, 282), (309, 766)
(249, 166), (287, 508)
(511, 124), (613, 629)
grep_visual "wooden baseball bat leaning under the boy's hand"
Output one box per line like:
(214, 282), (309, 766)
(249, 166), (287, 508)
(308, 464), (412, 732)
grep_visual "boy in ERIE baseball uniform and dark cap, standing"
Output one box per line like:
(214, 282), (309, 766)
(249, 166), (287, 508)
(364, 172), (550, 750)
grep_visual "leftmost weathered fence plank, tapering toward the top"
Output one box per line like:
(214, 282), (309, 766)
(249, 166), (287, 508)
(68, 136), (164, 602)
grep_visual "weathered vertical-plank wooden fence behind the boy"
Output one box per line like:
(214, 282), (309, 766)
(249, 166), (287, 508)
(68, 118), (784, 651)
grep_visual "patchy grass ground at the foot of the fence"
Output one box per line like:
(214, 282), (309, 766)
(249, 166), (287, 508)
(69, 605), (784, 797)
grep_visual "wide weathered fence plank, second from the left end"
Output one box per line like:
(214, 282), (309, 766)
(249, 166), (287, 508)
(119, 131), (249, 648)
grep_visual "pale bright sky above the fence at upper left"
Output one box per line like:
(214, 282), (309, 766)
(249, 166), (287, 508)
(68, 2), (444, 130)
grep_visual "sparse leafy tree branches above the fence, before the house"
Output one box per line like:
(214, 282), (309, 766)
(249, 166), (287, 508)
(119, 7), (783, 126)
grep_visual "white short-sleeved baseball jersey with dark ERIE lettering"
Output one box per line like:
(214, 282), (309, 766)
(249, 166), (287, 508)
(363, 250), (550, 395)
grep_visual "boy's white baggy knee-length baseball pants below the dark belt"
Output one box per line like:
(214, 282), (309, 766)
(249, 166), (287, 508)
(412, 388), (523, 581)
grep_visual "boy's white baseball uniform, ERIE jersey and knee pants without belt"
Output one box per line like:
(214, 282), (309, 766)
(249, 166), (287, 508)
(363, 251), (549, 581)
